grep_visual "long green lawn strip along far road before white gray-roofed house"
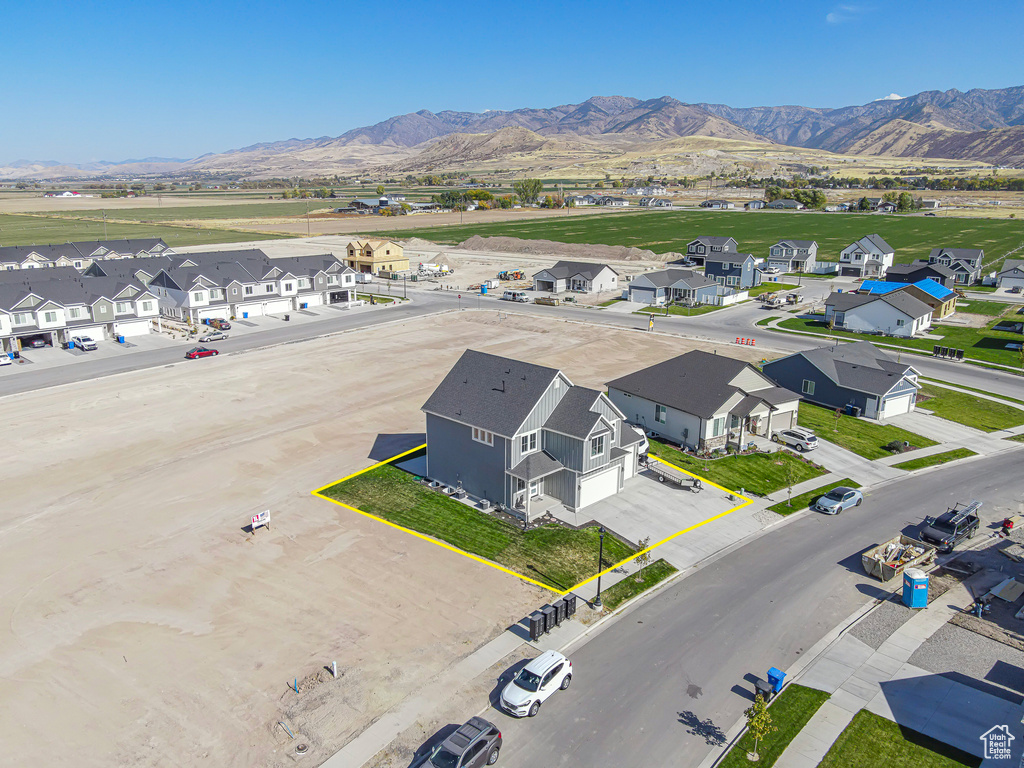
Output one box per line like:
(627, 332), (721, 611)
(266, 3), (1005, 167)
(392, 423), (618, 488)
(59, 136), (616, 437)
(777, 317), (1022, 368)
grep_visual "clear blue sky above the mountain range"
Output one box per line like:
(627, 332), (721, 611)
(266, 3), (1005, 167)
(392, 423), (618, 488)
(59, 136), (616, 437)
(0, 0), (1024, 162)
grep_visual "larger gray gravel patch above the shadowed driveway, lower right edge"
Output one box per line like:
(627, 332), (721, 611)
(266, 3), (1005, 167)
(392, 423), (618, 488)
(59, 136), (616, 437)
(909, 624), (1024, 703)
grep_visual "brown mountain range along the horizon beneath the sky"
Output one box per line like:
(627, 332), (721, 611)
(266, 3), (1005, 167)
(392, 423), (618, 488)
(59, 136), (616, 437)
(8, 86), (1024, 178)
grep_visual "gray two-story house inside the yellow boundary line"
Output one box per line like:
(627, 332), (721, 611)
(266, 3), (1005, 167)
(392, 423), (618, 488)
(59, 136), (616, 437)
(422, 349), (642, 521)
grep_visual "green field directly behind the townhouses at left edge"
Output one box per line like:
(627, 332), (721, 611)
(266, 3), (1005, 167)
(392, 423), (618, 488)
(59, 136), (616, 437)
(0, 209), (281, 248)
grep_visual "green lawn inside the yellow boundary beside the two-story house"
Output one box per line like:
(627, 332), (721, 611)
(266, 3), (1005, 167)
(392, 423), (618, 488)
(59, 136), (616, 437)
(323, 464), (634, 590)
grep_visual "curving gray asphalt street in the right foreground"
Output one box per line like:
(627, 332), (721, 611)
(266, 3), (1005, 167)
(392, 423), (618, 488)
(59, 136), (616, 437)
(488, 451), (1022, 768)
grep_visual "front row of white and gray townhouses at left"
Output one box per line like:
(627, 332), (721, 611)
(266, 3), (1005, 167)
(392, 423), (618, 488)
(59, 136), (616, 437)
(0, 250), (356, 351)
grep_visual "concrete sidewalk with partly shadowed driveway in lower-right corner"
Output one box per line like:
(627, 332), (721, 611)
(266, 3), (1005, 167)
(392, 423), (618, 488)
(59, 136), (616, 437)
(775, 580), (1024, 768)
